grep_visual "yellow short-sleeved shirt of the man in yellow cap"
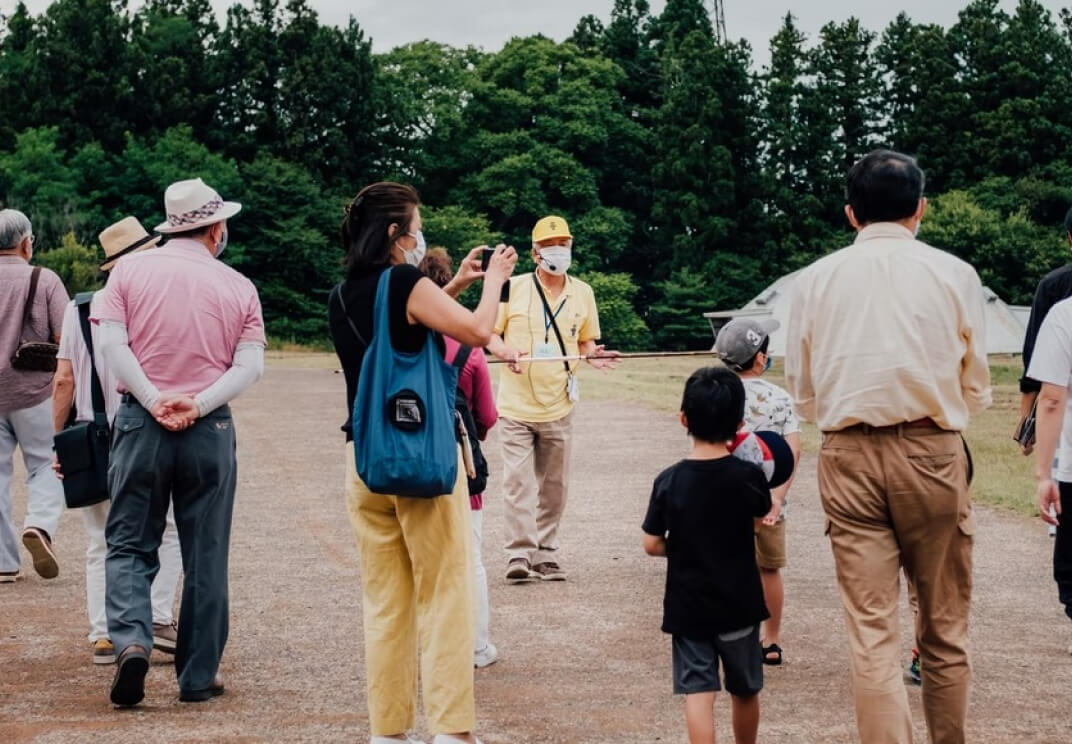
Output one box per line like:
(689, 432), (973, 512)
(495, 273), (600, 423)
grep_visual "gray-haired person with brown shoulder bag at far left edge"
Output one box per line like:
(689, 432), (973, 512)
(0, 209), (68, 583)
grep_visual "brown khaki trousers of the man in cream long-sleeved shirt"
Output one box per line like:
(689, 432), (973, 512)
(819, 426), (974, 744)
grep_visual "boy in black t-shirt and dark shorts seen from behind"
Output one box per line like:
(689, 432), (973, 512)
(643, 367), (771, 744)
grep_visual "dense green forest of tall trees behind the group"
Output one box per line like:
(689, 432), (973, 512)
(0, 0), (1072, 348)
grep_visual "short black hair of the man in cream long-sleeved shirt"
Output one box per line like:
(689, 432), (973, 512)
(845, 150), (924, 225)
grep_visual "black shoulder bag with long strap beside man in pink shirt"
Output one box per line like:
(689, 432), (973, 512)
(53, 293), (111, 509)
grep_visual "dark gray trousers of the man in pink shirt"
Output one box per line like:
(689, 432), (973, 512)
(105, 399), (237, 693)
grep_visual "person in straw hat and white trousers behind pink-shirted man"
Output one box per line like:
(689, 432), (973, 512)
(53, 217), (182, 664)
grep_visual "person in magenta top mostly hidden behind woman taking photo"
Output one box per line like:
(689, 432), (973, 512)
(420, 248), (498, 668)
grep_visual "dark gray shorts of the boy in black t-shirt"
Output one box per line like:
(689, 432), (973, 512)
(673, 625), (763, 698)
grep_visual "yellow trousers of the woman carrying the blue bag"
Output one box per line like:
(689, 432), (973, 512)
(346, 443), (476, 736)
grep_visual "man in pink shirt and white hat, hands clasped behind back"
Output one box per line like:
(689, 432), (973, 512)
(95, 178), (265, 705)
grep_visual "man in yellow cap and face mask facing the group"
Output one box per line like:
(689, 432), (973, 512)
(488, 215), (620, 583)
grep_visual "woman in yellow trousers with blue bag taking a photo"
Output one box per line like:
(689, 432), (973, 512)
(328, 182), (517, 744)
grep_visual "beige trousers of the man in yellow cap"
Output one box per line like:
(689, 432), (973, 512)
(498, 412), (574, 565)
